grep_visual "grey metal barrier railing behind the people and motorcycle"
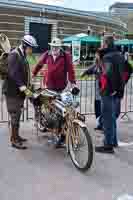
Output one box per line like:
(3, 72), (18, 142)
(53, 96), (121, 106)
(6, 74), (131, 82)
(0, 77), (133, 123)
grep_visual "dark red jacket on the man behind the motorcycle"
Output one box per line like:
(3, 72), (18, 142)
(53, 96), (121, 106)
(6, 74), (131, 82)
(33, 51), (75, 90)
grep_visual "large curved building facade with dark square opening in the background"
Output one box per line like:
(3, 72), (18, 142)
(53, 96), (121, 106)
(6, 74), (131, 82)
(0, 0), (127, 50)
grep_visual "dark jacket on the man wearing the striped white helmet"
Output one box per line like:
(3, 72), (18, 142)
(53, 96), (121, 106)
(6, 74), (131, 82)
(3, 48), (30, 98)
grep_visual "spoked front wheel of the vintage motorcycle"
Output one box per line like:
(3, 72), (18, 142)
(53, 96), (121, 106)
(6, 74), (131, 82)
(69, 125), (93, 172)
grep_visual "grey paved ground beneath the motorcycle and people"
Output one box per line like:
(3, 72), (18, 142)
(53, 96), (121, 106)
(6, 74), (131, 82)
(0, 116), (133, 200)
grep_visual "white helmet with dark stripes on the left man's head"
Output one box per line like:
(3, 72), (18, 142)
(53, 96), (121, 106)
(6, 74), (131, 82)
(22, 35), (38, 48)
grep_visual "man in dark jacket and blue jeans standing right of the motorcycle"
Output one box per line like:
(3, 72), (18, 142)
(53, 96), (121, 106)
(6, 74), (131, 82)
(95, 36), (129, 153)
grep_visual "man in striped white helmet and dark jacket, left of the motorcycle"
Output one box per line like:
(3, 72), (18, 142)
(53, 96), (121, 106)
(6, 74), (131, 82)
(3, 35), (37, 149)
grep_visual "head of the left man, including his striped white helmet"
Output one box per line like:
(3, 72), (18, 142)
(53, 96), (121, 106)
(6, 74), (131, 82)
(21, 35), (38, 55)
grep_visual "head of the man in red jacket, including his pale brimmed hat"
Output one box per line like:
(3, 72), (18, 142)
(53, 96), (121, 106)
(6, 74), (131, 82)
(49, 38), (62, 56)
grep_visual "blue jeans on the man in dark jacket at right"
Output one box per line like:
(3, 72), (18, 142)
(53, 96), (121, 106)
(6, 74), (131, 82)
(101, 96), (121, 145)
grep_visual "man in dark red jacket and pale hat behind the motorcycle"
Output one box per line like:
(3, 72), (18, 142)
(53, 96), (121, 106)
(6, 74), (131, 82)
(33, 38), (76, 147)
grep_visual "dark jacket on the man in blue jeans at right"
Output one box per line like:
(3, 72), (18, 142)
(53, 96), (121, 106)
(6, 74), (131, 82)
(100, 48), (125, 97)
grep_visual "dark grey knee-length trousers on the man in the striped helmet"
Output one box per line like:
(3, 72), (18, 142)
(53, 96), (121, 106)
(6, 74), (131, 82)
(6, 96), (24, 128)
